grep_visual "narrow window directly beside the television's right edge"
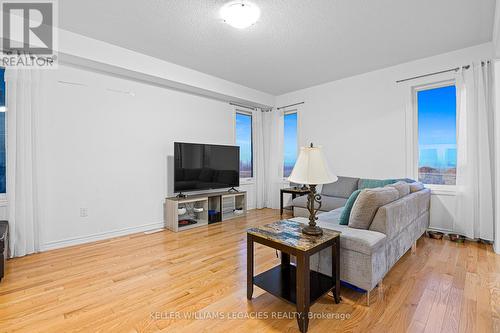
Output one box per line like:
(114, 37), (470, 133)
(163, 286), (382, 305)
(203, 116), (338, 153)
(236, 112), (253, 178)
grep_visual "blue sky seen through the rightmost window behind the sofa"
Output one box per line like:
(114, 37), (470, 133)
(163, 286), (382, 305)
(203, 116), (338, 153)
(417, 85), (457, 168)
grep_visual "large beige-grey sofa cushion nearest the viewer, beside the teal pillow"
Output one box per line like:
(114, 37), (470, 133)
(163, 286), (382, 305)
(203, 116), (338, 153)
(349, 187), (399, 229)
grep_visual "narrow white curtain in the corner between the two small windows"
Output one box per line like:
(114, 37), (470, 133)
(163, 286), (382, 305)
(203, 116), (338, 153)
(252, 109), (267, 209)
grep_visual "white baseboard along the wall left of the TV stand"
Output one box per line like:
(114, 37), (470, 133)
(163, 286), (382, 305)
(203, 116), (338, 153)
(40, 222), (165, 252)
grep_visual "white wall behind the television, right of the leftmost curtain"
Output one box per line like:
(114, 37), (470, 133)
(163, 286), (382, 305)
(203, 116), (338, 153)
(39, 66), (246, 249)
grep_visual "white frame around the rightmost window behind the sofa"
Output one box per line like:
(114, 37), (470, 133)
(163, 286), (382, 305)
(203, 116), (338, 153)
(409, 76), (458, 195)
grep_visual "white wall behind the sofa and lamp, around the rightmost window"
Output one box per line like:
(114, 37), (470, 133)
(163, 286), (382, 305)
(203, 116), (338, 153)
(276, 43), (493, 231)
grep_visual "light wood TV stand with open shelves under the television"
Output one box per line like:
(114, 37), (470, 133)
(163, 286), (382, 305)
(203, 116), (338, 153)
(164, 191), (247, 232)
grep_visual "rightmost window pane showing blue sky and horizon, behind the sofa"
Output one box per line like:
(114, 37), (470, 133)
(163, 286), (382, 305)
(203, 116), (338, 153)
(416, 84), (457, 185)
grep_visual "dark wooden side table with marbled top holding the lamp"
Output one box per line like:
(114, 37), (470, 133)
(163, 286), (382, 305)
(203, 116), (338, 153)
(247, 220), (340, 333)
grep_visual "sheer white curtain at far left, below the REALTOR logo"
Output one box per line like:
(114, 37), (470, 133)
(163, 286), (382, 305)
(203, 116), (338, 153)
(5, 69), (40, 257)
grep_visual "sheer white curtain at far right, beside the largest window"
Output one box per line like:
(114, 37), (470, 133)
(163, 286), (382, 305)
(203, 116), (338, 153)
(454, 62), (494, 240)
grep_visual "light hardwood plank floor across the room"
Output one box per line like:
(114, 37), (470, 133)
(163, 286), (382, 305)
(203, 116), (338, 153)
(0, 209), (500, 333)
